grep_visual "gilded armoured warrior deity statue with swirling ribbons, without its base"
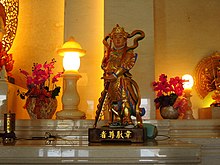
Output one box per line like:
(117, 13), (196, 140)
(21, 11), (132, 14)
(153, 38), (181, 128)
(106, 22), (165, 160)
(94, 25), (145, 127)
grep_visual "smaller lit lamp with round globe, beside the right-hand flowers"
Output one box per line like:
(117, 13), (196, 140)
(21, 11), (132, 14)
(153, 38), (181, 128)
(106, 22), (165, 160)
(182, 74), (194, 119)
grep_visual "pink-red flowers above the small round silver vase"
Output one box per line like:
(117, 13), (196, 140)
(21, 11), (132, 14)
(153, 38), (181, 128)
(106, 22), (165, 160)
(153, 74), (188, 113)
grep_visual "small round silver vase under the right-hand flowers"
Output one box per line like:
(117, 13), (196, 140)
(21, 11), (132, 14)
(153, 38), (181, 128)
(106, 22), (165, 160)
(160, 106), (179, 119)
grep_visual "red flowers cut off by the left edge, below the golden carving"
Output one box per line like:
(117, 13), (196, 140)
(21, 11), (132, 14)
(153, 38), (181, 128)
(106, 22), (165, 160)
(0, 43), (14, 73)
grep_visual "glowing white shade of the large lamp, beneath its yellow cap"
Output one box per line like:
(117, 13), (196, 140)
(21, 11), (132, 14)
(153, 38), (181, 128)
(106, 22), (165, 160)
(63, 52), (80, 72)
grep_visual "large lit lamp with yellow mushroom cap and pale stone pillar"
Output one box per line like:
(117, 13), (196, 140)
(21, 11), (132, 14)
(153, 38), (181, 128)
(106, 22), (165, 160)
(56, 37), (86, 119)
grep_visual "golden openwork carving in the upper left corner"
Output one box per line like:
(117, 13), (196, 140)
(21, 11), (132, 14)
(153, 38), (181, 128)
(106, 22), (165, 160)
(0, 0), (19, 52)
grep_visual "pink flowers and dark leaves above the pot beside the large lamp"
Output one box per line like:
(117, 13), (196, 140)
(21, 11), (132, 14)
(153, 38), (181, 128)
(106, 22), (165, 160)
(18, 59), (63, 100)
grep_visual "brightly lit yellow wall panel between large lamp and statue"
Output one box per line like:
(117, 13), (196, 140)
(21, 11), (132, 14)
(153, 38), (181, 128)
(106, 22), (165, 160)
(65, 0), (104, 119)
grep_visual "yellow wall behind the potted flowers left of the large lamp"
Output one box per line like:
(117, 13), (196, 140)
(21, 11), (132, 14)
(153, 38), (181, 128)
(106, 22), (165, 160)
(10, 0), (64, 118)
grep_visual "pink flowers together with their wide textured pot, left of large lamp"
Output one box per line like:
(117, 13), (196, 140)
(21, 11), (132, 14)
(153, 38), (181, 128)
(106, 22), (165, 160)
(17, 59), (63, 119)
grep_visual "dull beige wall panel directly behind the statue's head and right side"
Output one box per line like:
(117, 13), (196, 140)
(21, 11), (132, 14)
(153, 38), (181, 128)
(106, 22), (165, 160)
(104, 0), (155, 118)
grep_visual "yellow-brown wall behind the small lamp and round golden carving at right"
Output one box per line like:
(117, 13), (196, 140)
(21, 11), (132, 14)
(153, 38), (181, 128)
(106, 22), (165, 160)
(155, 0), (220, 117)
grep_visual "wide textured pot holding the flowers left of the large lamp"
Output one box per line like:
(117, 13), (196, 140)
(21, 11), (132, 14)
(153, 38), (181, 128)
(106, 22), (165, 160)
(25, 97), (57, 119)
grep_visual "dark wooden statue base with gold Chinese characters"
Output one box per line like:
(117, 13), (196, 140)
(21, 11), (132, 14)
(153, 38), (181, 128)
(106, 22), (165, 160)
(88, 127), (146, 143)
